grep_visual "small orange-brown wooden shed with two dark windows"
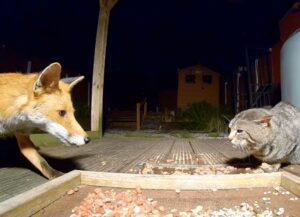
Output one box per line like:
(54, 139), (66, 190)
(177, 65), (220, 108)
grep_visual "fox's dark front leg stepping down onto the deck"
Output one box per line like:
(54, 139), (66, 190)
(15, 134), (63, 179)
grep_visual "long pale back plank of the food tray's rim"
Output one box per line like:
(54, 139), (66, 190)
(81, 171), (281, 190)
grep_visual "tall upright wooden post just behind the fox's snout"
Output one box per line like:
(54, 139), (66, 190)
(91, 0), (117, 136)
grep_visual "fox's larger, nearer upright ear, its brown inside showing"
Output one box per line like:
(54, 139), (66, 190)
(33, 63), (61, 92)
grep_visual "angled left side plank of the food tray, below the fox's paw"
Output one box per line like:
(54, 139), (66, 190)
(0, 170), (81, 217)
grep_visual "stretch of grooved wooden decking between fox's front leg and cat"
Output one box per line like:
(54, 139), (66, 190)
(37, 138), (246, 173)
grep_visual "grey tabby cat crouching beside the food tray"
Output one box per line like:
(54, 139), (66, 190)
(228, 102), (300, 171)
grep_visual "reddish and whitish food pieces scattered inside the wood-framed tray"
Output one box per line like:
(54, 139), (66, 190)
(70, 187), (298, 217)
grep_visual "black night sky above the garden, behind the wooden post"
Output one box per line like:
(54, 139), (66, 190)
(0, 0), (295, 108)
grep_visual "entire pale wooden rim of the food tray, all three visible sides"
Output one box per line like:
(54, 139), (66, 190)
(0, 170), (300, 217)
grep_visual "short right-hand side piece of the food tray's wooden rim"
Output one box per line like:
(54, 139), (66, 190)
(281, 171), (300, 197)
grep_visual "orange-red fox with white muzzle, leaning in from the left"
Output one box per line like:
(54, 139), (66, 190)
(0, 63), (90, 179)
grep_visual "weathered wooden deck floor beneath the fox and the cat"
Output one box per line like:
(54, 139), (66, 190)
(0, 137), (298, 201)
